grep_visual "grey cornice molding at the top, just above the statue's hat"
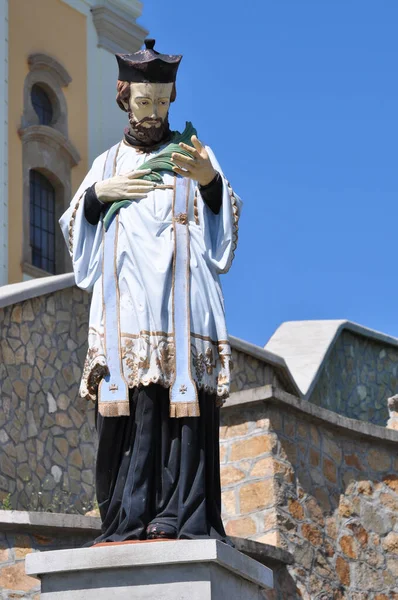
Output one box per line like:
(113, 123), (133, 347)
(91, 2), (148, 54)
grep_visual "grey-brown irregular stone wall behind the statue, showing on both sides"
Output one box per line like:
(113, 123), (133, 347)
(0, 287), (279, 513)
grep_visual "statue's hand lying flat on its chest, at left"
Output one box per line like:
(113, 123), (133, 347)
(95, 169), (154, 202)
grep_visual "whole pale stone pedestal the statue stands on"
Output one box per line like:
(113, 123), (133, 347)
(26, 540), (273, 600)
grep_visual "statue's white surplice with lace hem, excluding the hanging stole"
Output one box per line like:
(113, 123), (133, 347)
(60, 141), (241, 401)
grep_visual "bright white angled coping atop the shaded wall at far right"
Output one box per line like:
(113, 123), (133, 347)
(265, 319), (398, 399)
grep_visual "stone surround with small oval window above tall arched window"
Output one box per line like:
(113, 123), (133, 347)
(18, 53), (80, 278)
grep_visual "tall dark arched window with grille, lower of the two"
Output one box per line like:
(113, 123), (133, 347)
(29, 170), (56, 273)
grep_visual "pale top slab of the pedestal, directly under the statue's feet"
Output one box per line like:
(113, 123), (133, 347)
(25, 540), (273, 588)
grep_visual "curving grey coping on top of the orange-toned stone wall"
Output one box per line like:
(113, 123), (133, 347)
(223, 385), (398, 444)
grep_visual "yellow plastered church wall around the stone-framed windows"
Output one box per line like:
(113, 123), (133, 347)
(8, 0), (88, 283)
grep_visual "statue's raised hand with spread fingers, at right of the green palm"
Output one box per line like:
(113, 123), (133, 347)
(171, 135), (217, 185)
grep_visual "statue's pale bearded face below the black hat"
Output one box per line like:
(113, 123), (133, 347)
(126, 83), (173, 145)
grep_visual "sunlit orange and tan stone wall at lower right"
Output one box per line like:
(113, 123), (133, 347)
(221, 395), (398, 600)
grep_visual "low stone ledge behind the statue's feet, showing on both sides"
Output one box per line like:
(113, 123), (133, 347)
(0, 510), (293, 566)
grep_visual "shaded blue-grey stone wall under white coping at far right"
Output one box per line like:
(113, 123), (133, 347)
(309, 330), (398, 425)
